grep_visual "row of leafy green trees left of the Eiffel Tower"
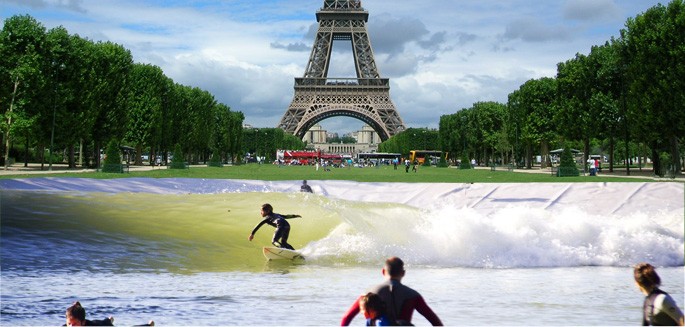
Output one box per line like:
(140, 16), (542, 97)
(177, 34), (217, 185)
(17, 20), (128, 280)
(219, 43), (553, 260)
(0, 15), (251, 168)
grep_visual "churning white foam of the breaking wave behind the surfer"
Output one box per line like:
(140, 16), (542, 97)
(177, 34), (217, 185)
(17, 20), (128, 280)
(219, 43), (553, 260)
(305, 204), (684, 268)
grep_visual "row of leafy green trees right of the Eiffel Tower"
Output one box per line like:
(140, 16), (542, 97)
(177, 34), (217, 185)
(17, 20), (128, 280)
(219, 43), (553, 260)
(387, 0), (685, 175)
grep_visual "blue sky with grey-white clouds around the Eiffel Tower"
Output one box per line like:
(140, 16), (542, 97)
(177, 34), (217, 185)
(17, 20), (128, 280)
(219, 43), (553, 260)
(0, 0), (666, 133)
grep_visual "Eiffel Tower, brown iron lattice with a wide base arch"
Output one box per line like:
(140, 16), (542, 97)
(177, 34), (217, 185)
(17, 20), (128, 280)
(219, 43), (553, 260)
(278, 0), (405, 141)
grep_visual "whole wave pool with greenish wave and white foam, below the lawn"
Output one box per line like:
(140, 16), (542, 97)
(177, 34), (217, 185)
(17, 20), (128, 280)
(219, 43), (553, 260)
(0, 179), (685, 325)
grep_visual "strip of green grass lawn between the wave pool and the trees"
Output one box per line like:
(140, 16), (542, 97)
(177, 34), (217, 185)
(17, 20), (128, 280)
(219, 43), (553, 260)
(0, 164), (654, 183)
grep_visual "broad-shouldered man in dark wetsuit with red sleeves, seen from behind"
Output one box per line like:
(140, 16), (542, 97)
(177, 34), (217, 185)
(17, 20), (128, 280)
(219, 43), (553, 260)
(340, 257), (443, 326)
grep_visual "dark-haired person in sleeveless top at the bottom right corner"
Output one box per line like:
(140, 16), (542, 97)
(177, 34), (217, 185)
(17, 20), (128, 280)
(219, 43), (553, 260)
(633, 263), (685, 326)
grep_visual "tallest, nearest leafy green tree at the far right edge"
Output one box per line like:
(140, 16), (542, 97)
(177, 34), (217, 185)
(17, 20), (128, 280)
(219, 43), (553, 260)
(621, 0), (685, 174)
